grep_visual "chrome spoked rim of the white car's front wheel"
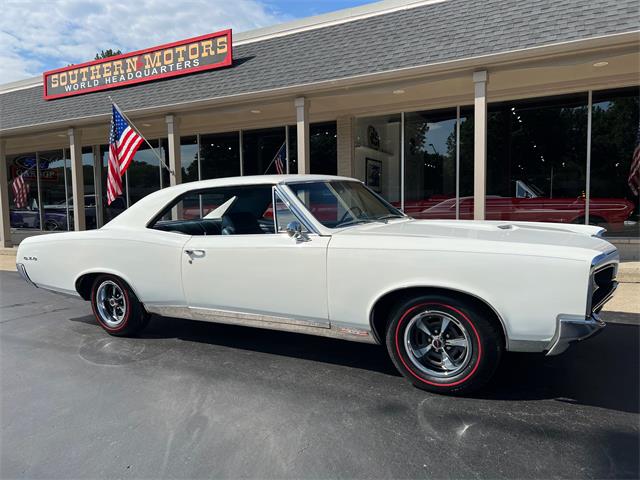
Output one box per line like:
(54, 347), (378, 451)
(404, 310), (473, 378)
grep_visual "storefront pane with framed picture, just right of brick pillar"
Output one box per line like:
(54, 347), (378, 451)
(353, 114), (401, 207)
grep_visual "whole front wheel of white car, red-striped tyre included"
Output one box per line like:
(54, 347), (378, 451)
(386, 295), (504, 393)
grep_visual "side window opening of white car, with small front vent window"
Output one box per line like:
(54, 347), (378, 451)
(149, 185), (304, 235)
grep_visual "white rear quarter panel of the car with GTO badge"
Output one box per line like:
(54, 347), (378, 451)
(17, 228), (188, 305)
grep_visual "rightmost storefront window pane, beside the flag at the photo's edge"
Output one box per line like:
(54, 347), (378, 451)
(589, 88), (640, 237)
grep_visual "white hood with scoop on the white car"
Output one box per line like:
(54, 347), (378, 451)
(340, 219), (615, 253)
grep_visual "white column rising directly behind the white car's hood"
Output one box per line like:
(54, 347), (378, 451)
(473, 70), (487, 220)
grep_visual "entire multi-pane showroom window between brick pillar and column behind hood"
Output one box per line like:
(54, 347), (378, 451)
(354, 107), (473, 219)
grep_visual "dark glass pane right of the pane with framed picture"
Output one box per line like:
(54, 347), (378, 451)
(404, 108), (457, 219)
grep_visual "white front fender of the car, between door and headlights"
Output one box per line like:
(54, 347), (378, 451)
(327, 235), (589, 342)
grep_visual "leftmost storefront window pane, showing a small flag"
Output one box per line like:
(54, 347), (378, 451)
(7, 153), (40, 229)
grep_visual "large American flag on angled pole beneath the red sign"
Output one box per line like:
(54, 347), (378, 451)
(107, 105), (144, 205)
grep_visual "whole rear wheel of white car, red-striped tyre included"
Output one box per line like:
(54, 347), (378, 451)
(91, 275), (149, 336)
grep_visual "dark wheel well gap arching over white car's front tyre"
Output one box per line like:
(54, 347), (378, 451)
(369, 287), (507, 345)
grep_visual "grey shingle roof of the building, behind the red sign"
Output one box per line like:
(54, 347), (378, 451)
(0, 0), (640, 130)
